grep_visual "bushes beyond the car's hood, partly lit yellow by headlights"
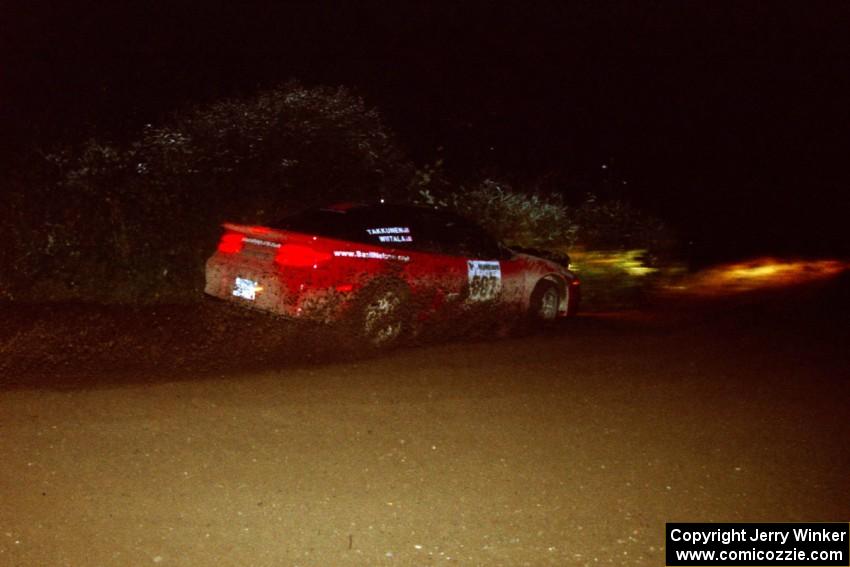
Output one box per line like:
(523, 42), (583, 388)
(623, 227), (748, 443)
(414, 178), (674, 309)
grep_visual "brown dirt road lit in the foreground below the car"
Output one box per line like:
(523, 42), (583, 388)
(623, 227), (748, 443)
(0, 281), (850, 566)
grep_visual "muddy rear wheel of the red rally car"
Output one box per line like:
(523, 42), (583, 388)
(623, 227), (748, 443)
(351, 281), (410, 349)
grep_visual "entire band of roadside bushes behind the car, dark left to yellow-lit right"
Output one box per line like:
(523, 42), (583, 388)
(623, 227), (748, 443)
(0, 82), (672, 302)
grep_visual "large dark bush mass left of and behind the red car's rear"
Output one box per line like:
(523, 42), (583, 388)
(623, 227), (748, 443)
(0, 82), (412, 301)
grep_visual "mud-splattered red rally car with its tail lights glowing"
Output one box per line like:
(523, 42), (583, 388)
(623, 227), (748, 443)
(205, 204), (579, 347)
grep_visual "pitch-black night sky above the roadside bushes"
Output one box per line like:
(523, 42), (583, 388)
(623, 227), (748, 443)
(0, 2), (850, 255)
